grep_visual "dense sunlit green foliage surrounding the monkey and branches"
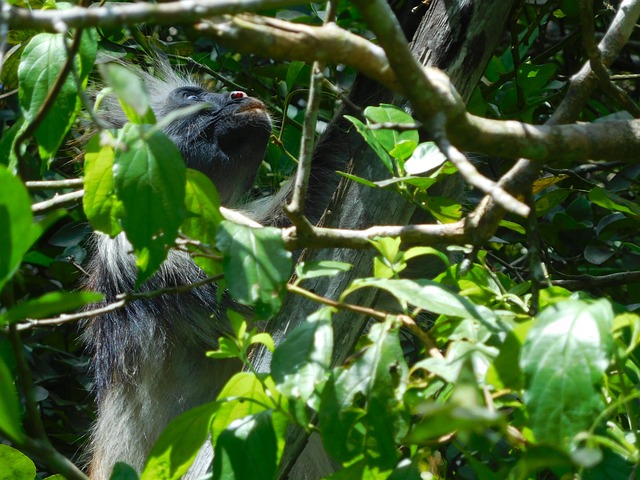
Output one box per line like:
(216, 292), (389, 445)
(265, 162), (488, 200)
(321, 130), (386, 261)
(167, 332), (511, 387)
(0, 0), (640, 480)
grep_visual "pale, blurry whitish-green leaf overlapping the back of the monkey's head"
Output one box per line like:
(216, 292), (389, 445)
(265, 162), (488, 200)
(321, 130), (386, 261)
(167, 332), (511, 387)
(100, 63), (156, 124)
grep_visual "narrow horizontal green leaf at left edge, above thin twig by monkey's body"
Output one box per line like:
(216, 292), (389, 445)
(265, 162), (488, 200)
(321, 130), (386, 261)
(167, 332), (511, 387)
(0, 291), (103, 326)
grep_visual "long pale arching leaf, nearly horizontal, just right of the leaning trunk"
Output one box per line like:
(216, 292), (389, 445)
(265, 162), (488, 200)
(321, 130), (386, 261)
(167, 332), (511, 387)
(340, 278), (495, 324)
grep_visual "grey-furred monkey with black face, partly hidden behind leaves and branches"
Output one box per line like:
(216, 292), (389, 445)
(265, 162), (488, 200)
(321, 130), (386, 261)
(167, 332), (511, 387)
(82, 65), (349, 480)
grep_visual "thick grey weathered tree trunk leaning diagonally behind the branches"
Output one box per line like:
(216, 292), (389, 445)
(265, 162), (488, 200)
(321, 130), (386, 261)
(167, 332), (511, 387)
(188, 0), (516, 478)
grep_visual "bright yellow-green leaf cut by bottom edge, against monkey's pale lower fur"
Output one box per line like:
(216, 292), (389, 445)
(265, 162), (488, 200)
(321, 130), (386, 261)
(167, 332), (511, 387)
(140, 402), (220, 480)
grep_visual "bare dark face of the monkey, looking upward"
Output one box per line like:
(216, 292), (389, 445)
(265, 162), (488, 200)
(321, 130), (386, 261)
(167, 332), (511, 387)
(158, 86), (271, 205)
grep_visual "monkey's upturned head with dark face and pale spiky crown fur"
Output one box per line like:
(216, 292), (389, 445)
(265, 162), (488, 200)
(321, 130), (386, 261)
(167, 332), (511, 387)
(102, 64), (271, 205)
